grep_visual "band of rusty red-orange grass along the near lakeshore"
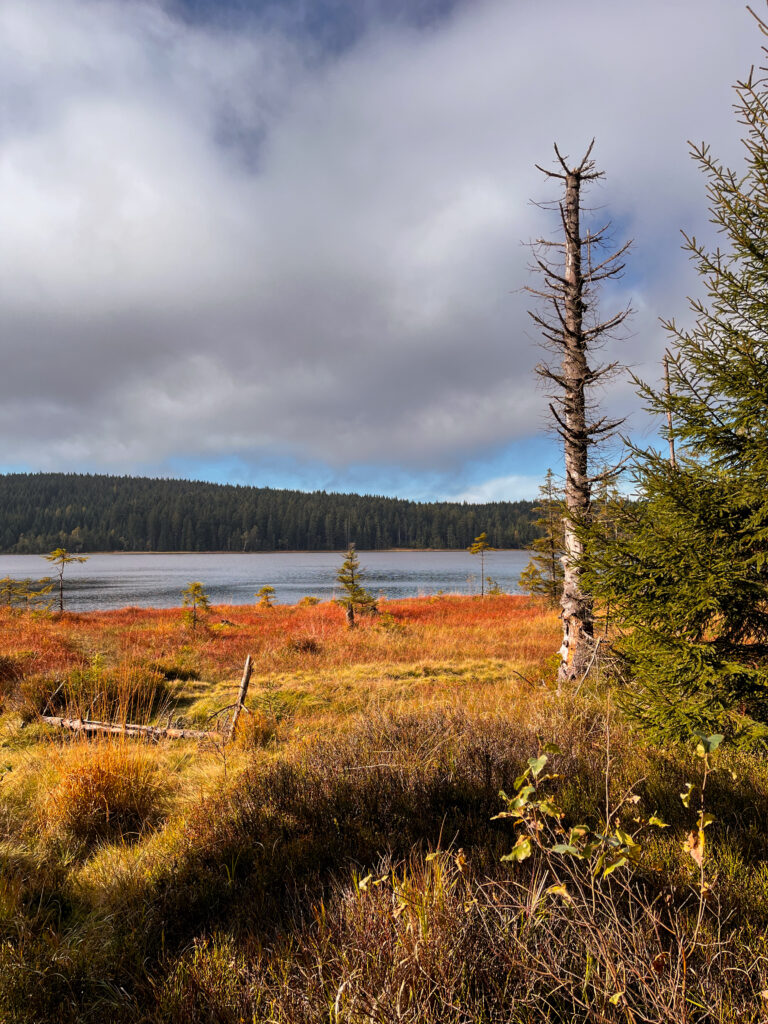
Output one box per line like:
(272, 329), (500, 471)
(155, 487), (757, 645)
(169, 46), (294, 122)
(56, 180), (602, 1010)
(0, 596), (556, 681)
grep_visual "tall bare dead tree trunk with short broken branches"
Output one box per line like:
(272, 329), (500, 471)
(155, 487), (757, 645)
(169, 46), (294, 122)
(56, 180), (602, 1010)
(527, 139), (630, 681)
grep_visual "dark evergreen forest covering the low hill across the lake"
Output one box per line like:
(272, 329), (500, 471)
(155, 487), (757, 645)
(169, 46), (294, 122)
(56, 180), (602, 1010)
(0, 473), (538, 554)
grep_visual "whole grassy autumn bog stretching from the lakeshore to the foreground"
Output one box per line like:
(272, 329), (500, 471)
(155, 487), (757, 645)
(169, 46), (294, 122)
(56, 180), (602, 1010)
(0, 596), (768, 1024)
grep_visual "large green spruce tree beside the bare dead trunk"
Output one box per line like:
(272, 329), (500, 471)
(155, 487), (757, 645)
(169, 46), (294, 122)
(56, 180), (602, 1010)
(585, 23), (768, 738)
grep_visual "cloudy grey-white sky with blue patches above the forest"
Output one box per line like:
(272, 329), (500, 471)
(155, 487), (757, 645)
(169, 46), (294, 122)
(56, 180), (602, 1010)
(0, 0), (763, 501)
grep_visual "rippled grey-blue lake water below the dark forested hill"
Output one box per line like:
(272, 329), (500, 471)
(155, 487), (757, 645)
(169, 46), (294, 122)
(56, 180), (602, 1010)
(0, 551), (530, 611)
